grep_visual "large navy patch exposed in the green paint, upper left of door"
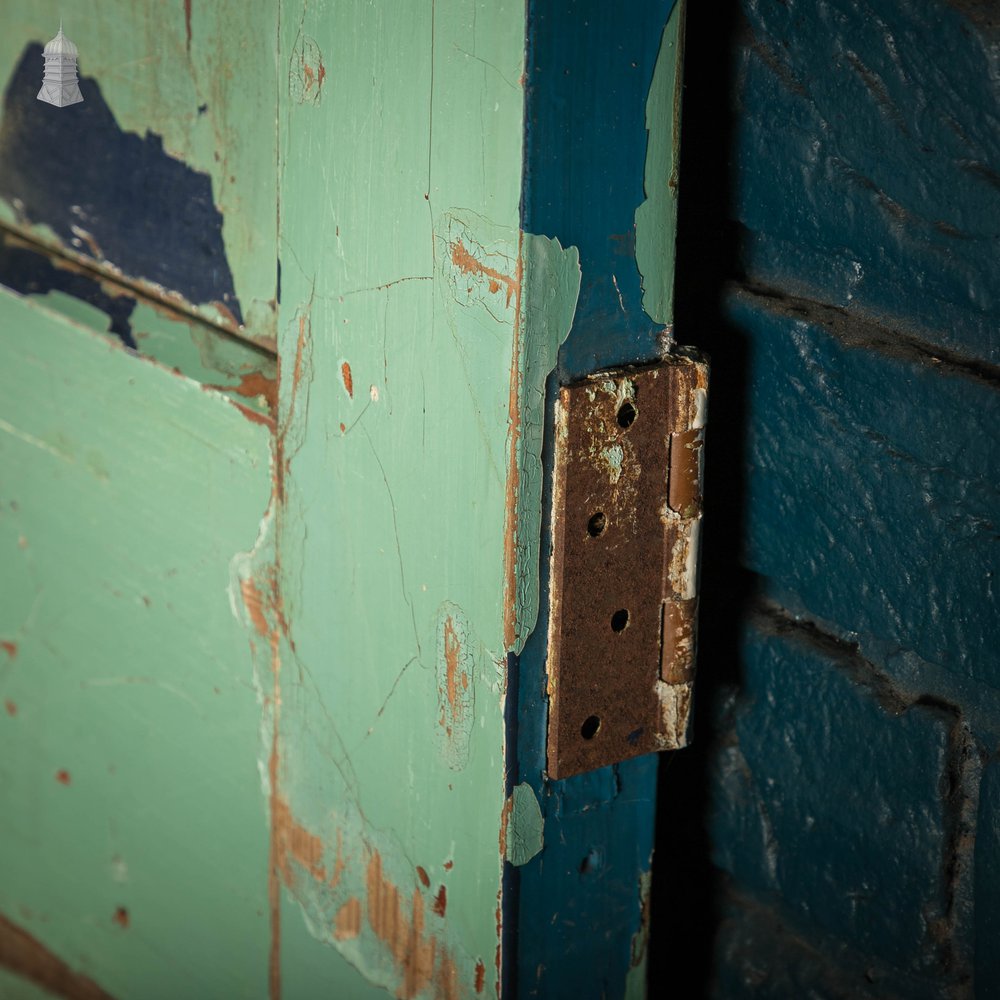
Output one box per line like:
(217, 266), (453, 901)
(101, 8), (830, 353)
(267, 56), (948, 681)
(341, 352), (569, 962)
(0, 44), (243, 325)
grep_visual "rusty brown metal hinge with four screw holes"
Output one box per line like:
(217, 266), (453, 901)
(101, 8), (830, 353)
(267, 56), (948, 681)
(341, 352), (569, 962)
(547, 352), (708, 778)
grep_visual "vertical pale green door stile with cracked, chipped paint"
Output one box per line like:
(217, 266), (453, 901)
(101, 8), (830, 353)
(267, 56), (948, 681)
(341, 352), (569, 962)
(231, 3), (580, 998)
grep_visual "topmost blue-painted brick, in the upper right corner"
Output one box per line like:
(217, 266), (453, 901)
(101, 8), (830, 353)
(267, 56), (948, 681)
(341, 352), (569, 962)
(733, 0), (1000, 363)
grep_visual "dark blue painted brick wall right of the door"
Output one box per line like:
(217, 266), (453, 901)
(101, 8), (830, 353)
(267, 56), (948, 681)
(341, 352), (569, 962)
(653, 0), (1000, 998)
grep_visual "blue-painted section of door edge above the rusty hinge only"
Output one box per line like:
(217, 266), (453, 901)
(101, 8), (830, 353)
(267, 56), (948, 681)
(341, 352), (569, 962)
(522, 0), (674, 380)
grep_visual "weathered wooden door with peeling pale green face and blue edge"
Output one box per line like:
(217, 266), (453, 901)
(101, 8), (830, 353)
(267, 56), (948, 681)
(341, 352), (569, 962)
(0, 0), (680, 1000)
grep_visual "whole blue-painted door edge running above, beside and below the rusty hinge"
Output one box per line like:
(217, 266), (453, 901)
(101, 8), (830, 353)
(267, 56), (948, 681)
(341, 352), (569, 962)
(504, 0), (673, 1000)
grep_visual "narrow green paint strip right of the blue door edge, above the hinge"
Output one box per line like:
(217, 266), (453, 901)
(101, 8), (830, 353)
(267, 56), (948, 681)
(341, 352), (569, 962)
(635, 0), (684, 326)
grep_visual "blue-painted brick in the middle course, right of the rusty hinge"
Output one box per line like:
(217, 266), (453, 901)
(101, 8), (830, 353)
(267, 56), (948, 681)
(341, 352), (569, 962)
(728, 289), (1000, 700)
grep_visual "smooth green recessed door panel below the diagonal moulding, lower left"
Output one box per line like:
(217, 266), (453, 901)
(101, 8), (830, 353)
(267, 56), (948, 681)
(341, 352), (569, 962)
(0, 292), (271, 997)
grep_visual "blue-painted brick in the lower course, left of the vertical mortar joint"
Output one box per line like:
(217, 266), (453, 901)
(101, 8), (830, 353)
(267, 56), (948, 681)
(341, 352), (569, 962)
(710, 618), (966, 983)
